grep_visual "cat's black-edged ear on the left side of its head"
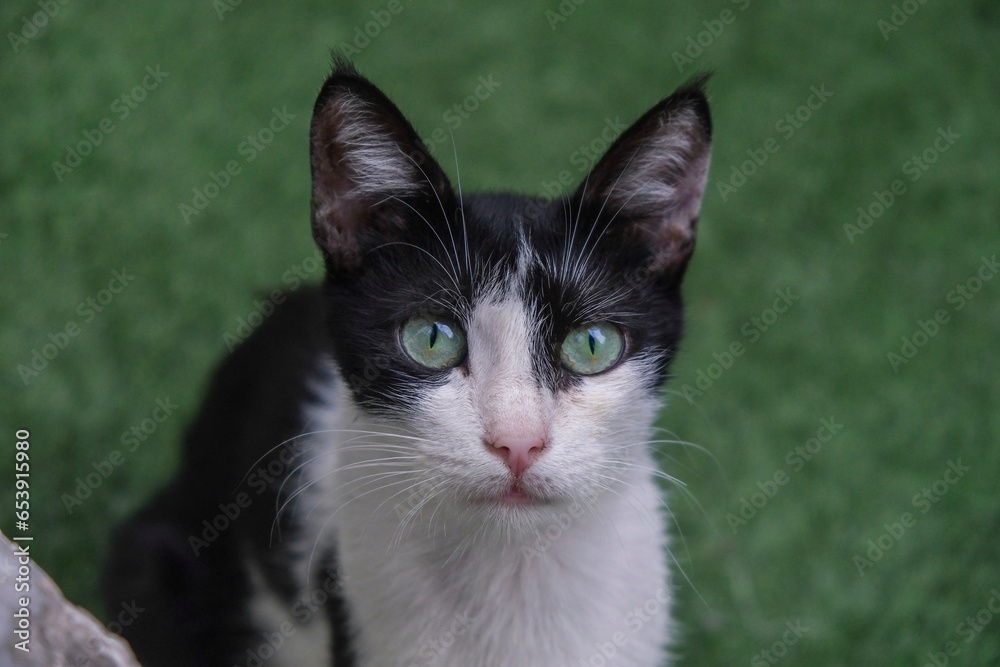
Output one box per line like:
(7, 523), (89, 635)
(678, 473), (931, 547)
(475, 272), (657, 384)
(309, 61), (454, 271)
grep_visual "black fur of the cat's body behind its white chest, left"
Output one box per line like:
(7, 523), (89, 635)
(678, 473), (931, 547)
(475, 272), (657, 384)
(103, 288), (352, 667)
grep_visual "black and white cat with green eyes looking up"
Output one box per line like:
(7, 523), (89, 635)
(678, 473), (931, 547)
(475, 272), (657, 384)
(104, 63), (711, 667)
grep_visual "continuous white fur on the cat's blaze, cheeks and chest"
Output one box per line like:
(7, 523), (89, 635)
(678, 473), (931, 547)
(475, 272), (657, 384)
(288, 280), (670, 667)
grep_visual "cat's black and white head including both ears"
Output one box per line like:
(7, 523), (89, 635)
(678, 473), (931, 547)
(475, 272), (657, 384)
(312, 68), (710, 532)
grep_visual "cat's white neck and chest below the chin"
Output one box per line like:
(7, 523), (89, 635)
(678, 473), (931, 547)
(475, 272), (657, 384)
(306, 378), (670, 667)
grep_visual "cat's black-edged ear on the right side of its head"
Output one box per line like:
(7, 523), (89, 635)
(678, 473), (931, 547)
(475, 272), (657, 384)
(575, 77), (712, 275)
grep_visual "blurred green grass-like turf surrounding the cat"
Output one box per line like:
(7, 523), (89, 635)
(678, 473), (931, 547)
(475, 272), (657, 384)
(0, 0), (1000, 666)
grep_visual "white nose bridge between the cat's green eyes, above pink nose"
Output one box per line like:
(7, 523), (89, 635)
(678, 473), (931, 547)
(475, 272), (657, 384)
(468, 296), (546, 440)
